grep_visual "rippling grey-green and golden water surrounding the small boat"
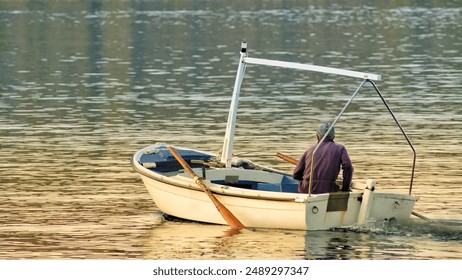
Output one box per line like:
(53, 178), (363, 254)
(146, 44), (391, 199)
(0, 0), (462, 260)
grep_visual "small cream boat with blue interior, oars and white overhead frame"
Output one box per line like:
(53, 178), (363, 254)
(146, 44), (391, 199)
(131, 42), (416, 230)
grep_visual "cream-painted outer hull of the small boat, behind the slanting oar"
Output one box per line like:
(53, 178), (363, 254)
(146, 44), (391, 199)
(142, 173), (361, 230)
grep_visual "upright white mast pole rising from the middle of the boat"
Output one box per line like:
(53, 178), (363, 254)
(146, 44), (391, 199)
(221, 42), (247, 168)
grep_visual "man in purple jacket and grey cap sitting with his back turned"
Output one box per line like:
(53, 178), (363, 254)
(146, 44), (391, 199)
(293, 123), (354, 194)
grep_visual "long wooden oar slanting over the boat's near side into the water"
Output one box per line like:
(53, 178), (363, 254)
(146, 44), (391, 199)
(168, 146), (244, 230)
